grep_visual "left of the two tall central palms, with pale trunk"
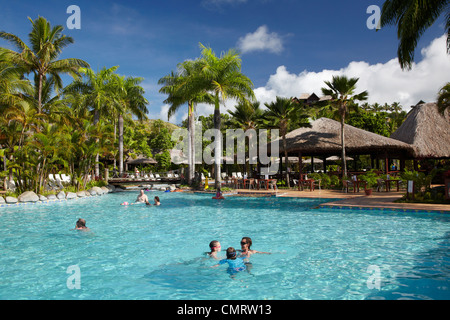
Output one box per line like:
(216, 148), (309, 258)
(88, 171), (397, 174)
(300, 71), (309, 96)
(158, 59), (213, 184)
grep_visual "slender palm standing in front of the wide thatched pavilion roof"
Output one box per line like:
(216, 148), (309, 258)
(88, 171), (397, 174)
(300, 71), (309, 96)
(322, 76), (368, 177)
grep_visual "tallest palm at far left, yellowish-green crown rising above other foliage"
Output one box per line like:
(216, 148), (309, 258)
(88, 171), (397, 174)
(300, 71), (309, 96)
(0, 17), (89, 113)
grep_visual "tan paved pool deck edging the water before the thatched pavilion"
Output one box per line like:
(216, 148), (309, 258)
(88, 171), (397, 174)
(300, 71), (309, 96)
(232, 189), (450, 214)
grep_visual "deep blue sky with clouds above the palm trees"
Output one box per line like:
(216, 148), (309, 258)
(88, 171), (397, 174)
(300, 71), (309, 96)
(0, 0), (450, 123)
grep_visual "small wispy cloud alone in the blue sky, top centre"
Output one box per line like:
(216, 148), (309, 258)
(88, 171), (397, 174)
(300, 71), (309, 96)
(237, 25), (284, 54)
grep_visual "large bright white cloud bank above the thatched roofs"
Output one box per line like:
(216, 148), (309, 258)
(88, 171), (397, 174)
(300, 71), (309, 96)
(255, 35), (450, 110)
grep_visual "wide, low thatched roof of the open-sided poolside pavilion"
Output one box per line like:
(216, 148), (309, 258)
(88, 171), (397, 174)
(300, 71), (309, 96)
(279, 118), (413, 157)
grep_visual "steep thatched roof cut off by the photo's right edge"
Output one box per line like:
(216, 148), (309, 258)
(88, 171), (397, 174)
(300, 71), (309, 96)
(391, 103), (450, 158)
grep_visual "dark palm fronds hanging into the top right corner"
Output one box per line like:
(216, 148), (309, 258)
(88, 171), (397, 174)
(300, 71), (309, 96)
(380, 0), (450, 69)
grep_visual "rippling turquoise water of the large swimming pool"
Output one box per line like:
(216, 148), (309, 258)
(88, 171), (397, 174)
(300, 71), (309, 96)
(0, 192), (450, 300)
